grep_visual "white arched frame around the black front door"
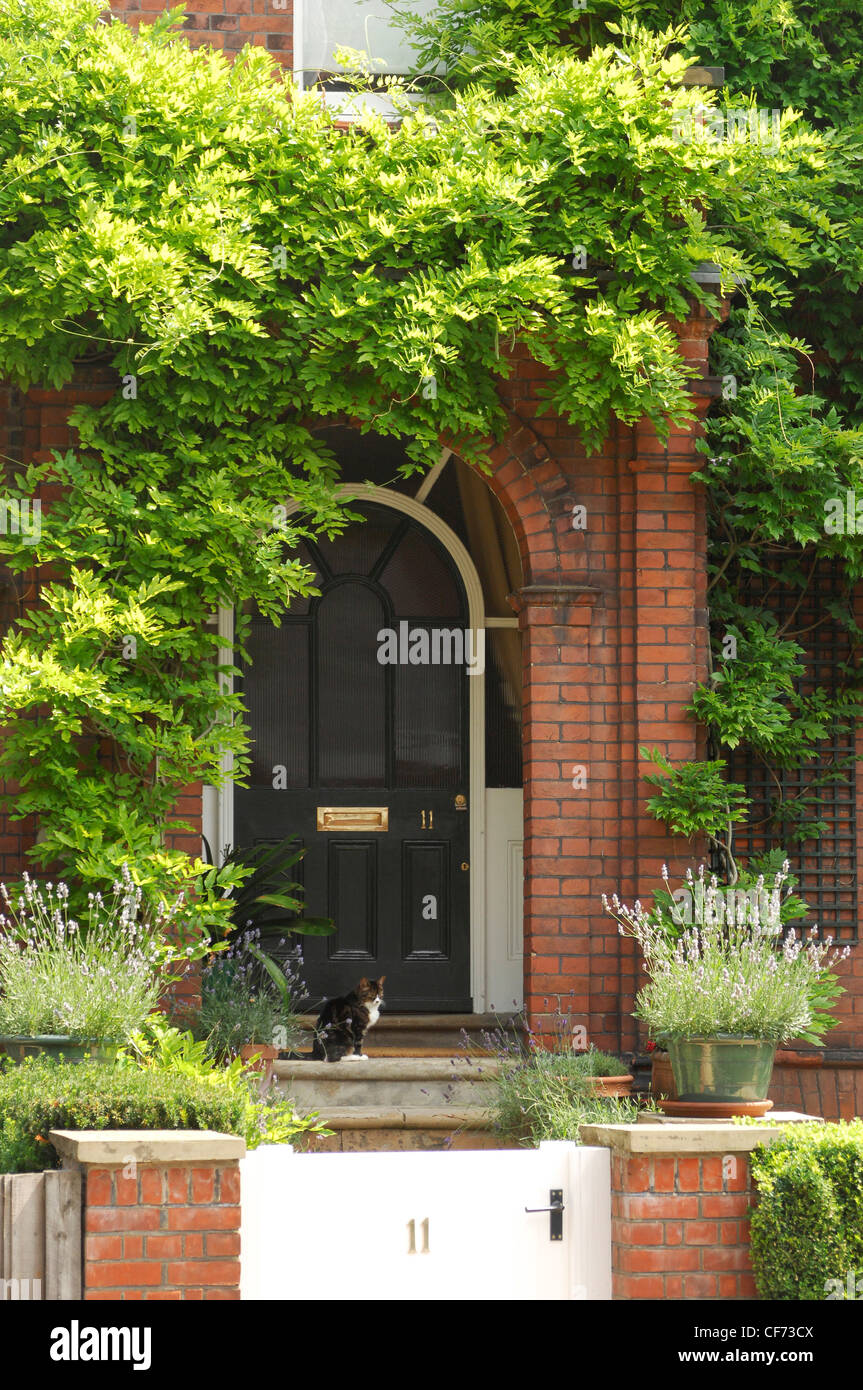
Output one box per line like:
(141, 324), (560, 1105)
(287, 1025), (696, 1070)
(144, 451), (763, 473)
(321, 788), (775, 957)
(212, 485), (488, 1013)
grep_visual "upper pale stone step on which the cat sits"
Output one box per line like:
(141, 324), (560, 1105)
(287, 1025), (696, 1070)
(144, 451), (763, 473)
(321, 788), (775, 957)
(272, 1055), (500, 1113)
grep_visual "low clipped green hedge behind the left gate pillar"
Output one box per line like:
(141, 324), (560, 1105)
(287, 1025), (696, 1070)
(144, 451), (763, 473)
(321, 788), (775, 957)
(0, 1058), (247, 1173)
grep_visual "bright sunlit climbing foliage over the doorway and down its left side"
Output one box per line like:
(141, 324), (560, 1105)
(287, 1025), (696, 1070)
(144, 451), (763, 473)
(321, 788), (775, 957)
(0, 0), (863, 900)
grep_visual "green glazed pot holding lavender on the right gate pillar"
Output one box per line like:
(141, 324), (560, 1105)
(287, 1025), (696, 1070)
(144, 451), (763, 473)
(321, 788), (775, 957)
(667, 1036), (775, 1101)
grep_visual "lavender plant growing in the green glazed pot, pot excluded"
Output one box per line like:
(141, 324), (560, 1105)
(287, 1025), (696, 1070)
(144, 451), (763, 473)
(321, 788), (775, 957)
(602, 860), (849, 1044)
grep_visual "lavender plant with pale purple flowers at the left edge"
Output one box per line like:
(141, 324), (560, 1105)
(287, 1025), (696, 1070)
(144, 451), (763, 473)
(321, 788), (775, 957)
(0, 866), (167, 1043)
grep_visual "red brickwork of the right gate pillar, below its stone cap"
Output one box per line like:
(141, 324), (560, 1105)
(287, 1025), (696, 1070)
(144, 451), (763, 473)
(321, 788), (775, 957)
(611, 1154), (756, 1300)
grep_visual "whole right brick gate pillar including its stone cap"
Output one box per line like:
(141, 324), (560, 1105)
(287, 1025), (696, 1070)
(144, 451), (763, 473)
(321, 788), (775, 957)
(572, 1116), (803, 1300)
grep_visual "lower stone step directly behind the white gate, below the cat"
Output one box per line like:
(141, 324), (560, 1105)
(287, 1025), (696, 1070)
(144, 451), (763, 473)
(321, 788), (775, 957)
(303, 1106), (505, 1154)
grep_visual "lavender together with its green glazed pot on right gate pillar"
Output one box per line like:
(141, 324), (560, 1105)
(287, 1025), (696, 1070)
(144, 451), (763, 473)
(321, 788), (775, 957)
(603, 863), (848, 1113)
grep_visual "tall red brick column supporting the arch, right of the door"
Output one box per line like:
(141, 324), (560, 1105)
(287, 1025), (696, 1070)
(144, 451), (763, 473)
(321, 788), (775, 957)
(517, 584), (596, 1026)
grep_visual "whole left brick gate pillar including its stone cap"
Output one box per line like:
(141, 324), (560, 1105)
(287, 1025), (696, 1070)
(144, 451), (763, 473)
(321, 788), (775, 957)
(50, 1130), (246, 1301)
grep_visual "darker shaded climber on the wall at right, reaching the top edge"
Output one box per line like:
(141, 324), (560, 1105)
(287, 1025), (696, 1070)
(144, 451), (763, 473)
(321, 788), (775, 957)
(408, 0), (863, 878)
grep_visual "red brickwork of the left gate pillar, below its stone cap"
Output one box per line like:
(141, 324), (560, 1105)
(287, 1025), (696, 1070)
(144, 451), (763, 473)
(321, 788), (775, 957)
(83, 1162), (240, 1300)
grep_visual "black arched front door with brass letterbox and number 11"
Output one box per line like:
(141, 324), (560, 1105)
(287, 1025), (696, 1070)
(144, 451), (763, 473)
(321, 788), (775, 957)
(235, 503), (472, 1012)
